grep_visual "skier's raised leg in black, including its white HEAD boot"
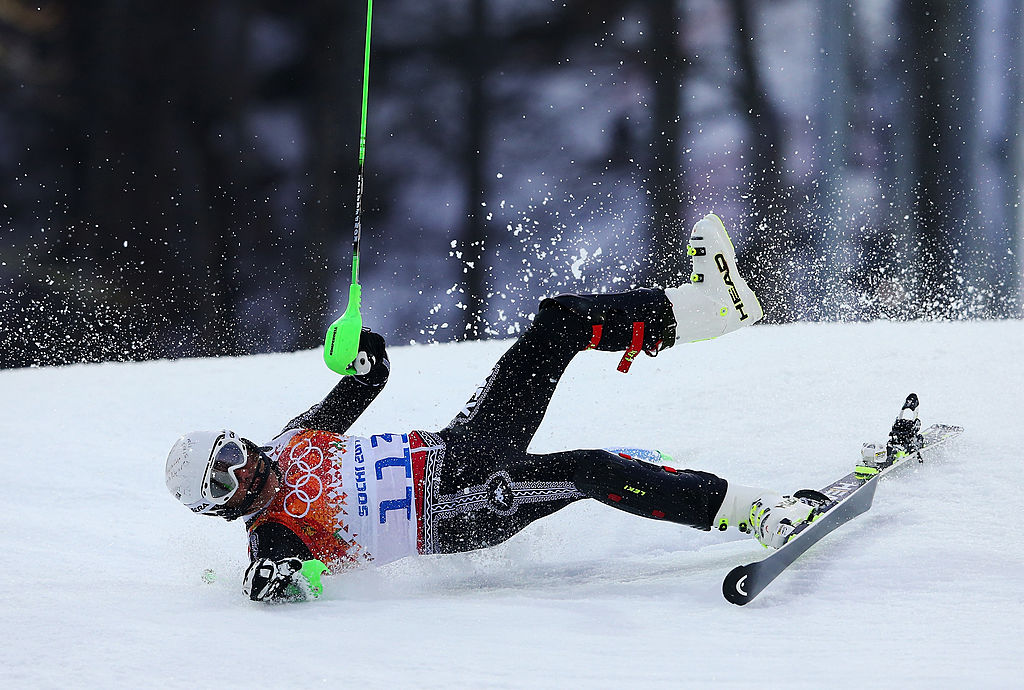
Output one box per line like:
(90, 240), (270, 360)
(440, 215), (764, 450)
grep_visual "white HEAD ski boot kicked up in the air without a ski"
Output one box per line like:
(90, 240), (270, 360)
(665, 214), (764, 343)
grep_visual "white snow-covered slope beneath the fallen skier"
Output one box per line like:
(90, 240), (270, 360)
(0, 321), (1024, 688)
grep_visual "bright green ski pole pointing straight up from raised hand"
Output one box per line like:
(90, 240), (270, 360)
(324, 0), (374, 376)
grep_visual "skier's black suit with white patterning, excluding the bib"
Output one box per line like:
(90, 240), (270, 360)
(250, 290), (727, 559)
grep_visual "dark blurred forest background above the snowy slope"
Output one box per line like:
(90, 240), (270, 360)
(0, 0), (1024, 366)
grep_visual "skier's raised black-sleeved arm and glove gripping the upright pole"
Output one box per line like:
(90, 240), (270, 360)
(285, 330), (391, 434)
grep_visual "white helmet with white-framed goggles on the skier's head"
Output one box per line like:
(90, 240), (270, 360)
(165, 429), (276, 520)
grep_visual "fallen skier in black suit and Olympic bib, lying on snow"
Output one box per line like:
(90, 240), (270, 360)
(166, 215), (815, 601)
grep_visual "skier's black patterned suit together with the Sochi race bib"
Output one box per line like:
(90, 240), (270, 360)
(246, 290), (726, 572)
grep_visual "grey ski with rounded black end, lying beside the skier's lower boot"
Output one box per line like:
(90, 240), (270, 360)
(722, 393), (964, 606)
